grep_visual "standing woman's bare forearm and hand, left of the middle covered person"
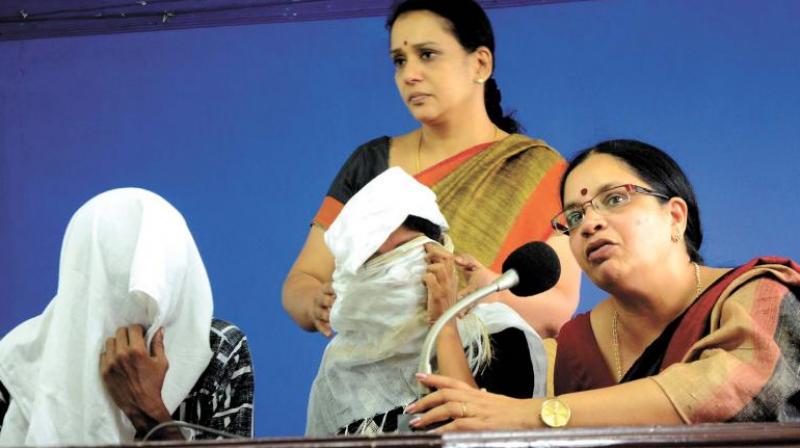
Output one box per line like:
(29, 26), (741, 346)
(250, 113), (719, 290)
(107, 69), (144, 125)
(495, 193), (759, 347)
(283, 225), (336, 336)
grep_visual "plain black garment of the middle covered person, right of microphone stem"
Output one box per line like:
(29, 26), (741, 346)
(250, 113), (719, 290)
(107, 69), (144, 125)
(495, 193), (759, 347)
(475, 328), (534, 398)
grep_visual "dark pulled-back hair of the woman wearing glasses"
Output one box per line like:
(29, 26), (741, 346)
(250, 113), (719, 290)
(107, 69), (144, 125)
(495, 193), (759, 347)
(561, 140), (703, 262)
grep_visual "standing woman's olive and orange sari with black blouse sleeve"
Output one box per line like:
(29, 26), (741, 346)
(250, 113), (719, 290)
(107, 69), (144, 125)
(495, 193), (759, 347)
(314, 134), (566, 272)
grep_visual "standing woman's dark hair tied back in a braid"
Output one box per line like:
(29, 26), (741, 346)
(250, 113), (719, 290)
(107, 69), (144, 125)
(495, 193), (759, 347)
(386, 0), (522, 133)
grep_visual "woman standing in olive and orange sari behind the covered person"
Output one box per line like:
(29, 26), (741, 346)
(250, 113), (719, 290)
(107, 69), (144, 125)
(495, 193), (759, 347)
(283, 0), (580, 337)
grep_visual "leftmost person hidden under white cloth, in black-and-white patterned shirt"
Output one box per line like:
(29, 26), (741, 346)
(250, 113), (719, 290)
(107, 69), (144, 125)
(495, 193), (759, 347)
(0, 188), (253, 446)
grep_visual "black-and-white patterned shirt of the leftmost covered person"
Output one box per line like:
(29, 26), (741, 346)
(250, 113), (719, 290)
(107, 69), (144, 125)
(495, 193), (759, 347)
(0, 319), (254, 440)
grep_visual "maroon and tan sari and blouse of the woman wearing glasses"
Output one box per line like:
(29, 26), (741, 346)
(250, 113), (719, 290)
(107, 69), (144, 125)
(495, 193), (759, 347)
(555, 257), (800, 423)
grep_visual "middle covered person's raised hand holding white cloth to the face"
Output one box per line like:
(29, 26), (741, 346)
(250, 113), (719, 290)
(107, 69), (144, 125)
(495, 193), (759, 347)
(422, 243), (458, 323)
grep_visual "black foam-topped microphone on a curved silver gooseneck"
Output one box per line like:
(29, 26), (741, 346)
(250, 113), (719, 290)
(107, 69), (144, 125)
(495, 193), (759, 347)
(417, 241), (561, 396)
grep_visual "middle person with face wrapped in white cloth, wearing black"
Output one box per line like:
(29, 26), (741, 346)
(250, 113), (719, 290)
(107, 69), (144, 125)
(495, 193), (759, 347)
(306, 168), (546, 436)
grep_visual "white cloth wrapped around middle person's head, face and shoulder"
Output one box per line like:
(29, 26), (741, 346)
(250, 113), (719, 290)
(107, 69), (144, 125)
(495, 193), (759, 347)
(306, 168), (546, 436)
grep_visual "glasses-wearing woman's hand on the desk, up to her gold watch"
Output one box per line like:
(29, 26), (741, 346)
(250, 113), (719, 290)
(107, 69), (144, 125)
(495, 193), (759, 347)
(406, 374), (540, 433)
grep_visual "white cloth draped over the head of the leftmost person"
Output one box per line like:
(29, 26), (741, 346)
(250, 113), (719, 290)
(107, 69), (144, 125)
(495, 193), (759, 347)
(0, 188), (213, 445)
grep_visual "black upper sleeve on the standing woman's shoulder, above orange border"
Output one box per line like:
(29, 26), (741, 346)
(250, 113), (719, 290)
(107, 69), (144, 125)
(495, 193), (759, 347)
(328, 136), (389, 204)
